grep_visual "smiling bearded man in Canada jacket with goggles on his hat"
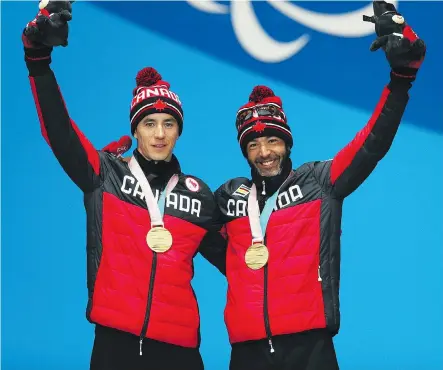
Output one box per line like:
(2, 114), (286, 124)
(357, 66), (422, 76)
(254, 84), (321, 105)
(215, 2), (425, 370)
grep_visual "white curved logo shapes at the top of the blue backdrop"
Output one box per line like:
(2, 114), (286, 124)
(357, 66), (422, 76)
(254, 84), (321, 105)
(187, 0), (398, 63)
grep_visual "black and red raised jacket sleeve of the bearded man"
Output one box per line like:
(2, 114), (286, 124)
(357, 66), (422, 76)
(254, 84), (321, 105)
(314, 74), (412, 198)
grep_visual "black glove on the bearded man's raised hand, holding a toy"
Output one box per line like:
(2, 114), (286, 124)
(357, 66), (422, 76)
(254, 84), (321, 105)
(363, 1), (426, 79)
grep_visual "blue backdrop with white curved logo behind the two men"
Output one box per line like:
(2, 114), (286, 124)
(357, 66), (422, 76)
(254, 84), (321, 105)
(1, 1), (443, 370)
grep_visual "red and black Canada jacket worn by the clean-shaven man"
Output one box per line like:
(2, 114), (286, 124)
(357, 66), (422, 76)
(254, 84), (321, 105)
(27, 61), (225, 347)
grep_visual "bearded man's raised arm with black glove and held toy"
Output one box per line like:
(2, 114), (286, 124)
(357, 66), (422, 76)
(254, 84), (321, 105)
(315, 2), (426, 198)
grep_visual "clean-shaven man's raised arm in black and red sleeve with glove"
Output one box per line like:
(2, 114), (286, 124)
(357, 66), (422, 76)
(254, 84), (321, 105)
(22, 1), (100, 192)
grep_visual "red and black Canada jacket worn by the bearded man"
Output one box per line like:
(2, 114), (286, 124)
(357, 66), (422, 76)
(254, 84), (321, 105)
(215, 76), (411, 343)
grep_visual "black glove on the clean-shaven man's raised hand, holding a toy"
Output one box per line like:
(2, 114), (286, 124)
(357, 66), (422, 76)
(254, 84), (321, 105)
(22, 0), (73, 61)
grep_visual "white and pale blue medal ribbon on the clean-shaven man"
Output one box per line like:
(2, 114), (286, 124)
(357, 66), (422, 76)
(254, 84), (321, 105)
(129, 156), (178, 227)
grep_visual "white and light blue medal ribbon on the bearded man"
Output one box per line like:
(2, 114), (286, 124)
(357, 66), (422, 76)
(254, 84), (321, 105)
(248, 171), (292, 244)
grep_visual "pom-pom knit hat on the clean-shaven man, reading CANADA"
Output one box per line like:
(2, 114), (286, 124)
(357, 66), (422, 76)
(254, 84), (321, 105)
(129, 67), (183, 135)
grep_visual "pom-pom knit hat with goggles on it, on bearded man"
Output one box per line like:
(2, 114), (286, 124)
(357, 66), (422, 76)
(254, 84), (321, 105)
(236, 86), (293, 157)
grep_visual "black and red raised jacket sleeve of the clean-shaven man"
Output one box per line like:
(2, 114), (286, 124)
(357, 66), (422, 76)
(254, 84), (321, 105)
(26, 60), (101, 193)
